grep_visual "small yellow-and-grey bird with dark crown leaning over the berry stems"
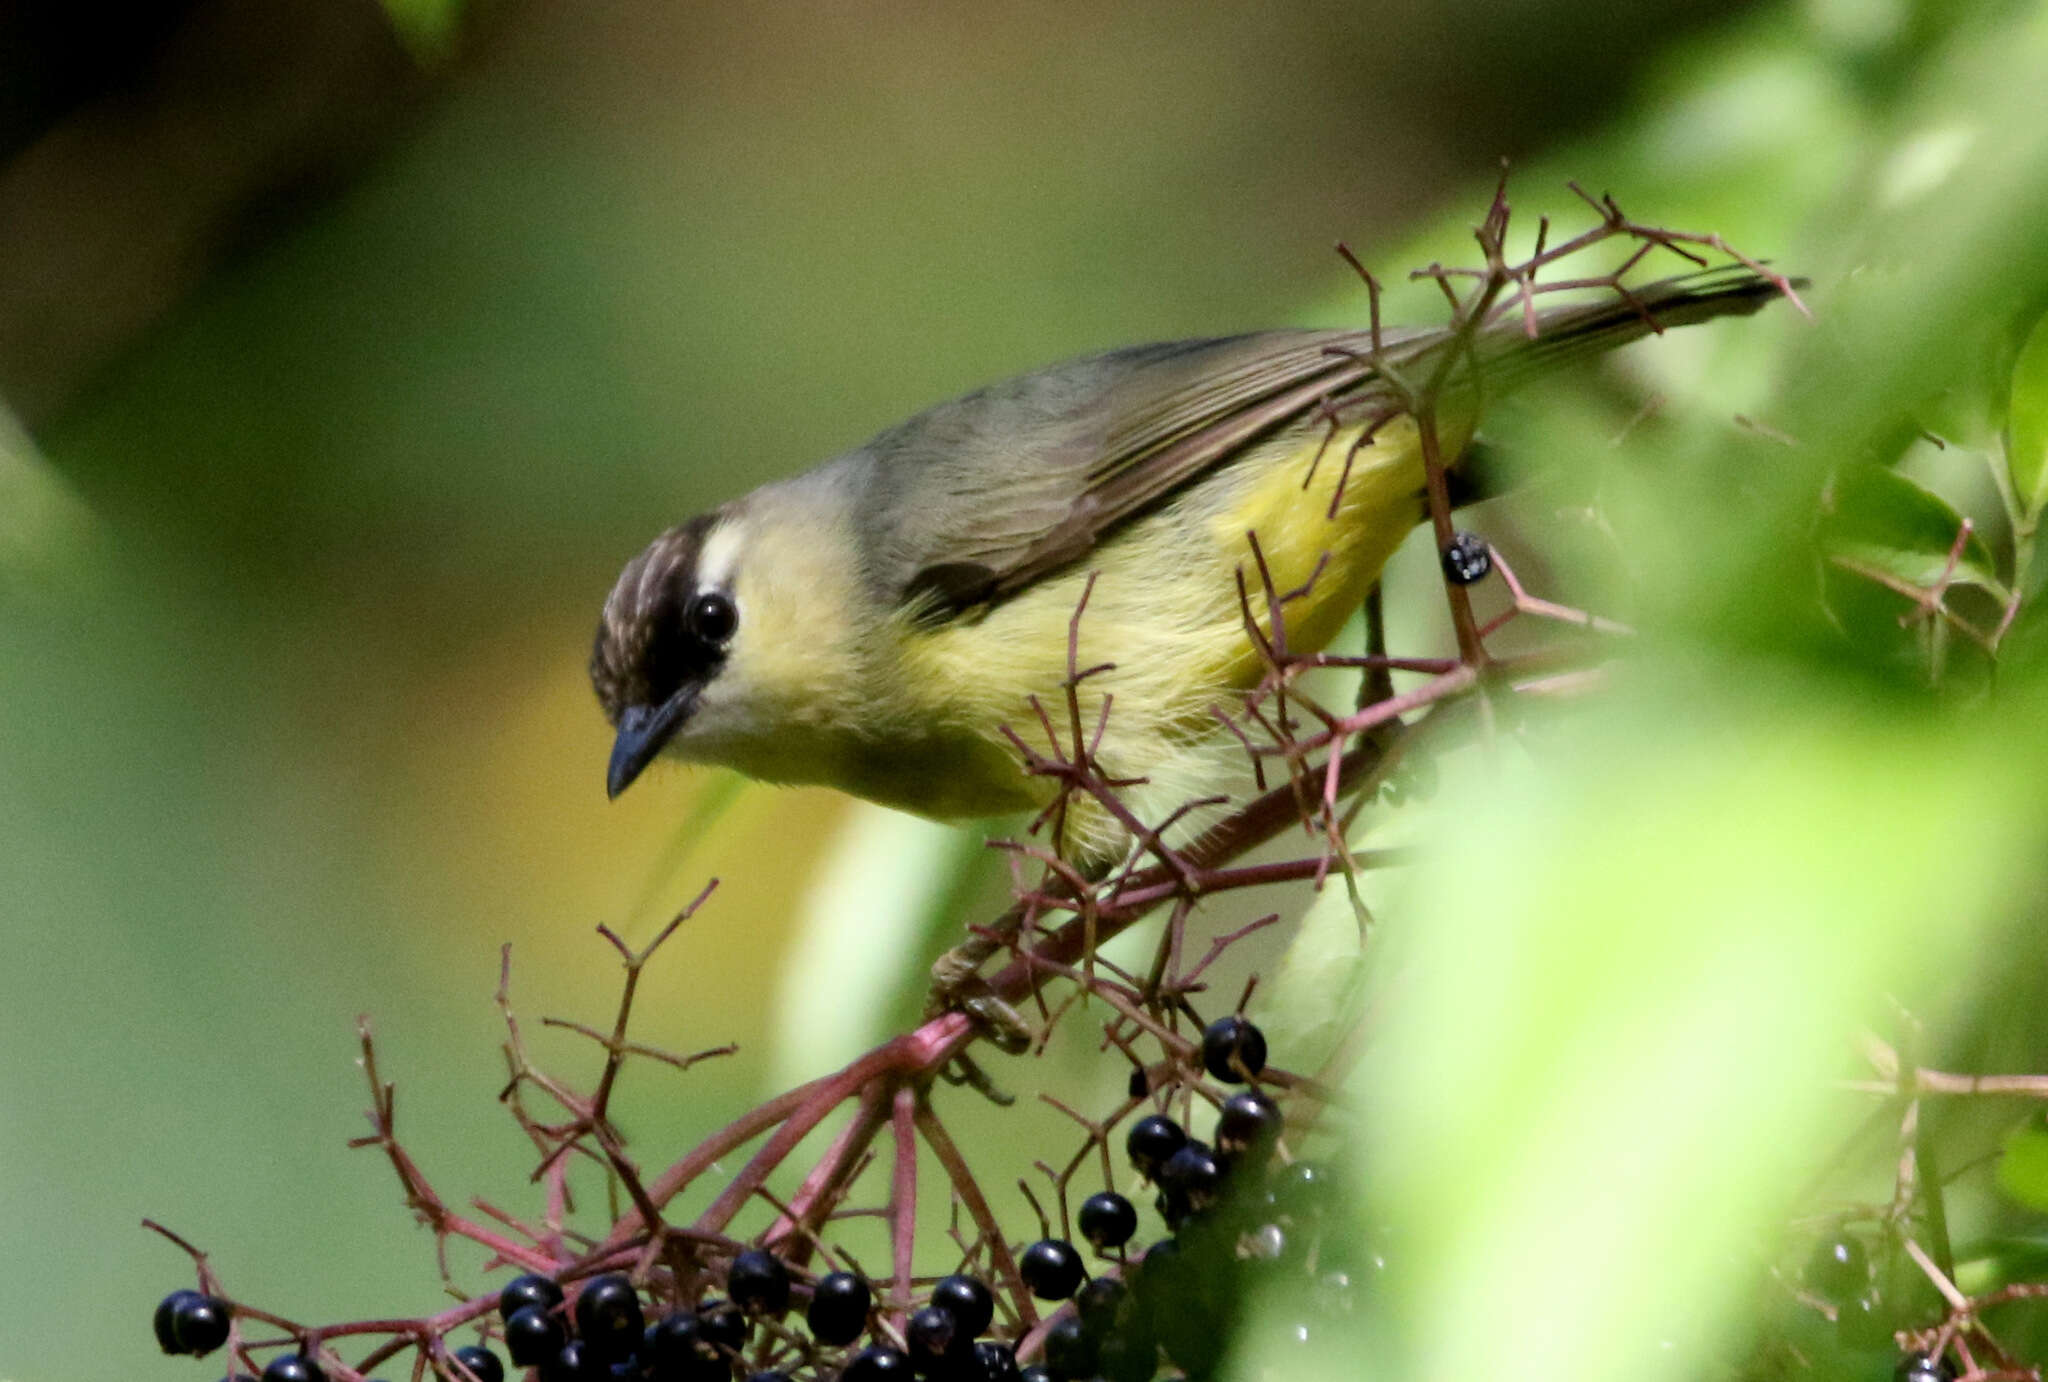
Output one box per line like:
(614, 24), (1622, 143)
(590, 270), (1778, 854)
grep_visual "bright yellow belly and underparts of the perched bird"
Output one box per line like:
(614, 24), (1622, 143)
(885, 418), (1456, 829)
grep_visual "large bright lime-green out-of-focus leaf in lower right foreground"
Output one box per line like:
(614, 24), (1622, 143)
(1354, 665), (2040, 1382)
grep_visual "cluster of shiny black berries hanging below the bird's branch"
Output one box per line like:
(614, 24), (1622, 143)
(156, 1016), (1327, 1382)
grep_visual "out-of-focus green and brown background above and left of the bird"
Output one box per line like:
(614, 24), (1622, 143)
(12, 0), (2038, 1382)
